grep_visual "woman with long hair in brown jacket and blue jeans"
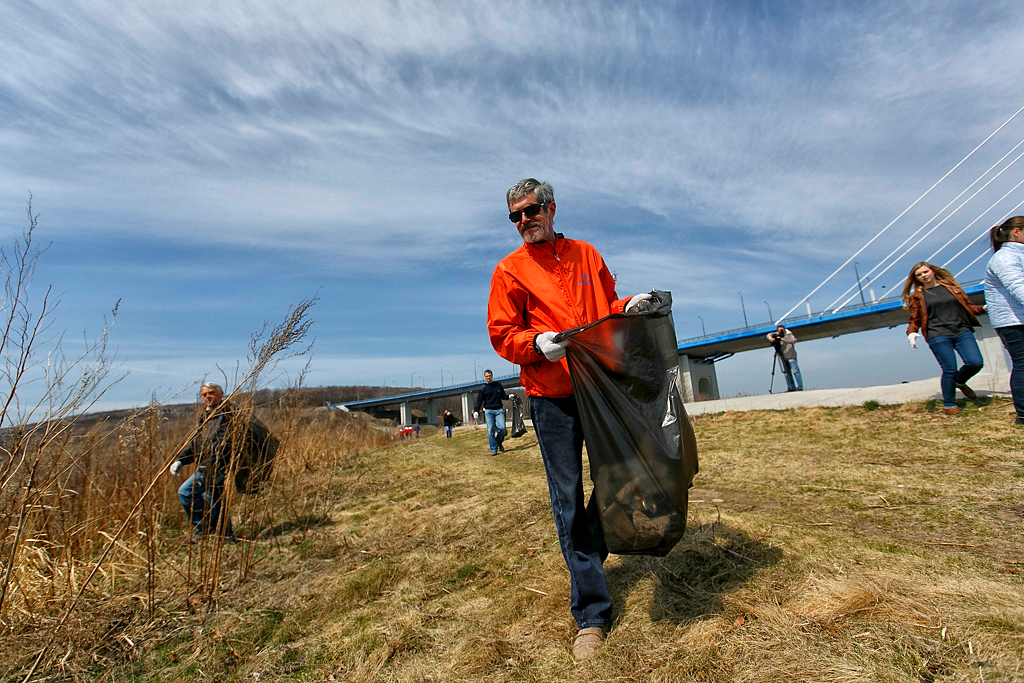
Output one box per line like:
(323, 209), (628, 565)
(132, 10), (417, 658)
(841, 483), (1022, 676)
(903, 261), (984, 415)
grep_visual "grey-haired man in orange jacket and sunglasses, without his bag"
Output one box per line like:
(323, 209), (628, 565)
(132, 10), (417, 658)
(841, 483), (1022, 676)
(487, 178), (650, 660)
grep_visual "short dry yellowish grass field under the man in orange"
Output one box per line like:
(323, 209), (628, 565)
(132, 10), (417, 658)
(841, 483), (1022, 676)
(0, 400), (1024, 683)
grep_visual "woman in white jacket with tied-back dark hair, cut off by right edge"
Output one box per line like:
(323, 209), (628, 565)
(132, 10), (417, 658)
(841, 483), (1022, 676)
(985, 216), (1024, 425)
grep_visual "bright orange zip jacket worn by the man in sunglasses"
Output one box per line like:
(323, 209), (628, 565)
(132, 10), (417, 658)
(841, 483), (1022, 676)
(487, 233), (629, 398)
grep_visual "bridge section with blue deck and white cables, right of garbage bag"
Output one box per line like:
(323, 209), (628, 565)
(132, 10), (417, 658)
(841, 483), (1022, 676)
(679, 108), (1024, 399)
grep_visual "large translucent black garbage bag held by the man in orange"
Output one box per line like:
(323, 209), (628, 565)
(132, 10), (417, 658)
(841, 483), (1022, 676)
(555, 290), (697, 556)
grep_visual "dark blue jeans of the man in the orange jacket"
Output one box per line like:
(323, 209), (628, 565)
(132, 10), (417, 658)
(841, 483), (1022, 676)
(529, 396), (611, 629)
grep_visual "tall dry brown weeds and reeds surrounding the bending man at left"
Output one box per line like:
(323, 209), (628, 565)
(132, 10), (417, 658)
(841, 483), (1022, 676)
(0, 198), (387, 680)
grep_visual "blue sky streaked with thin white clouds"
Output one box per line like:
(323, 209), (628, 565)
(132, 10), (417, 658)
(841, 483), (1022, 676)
(0, 0), (1024, 407)
